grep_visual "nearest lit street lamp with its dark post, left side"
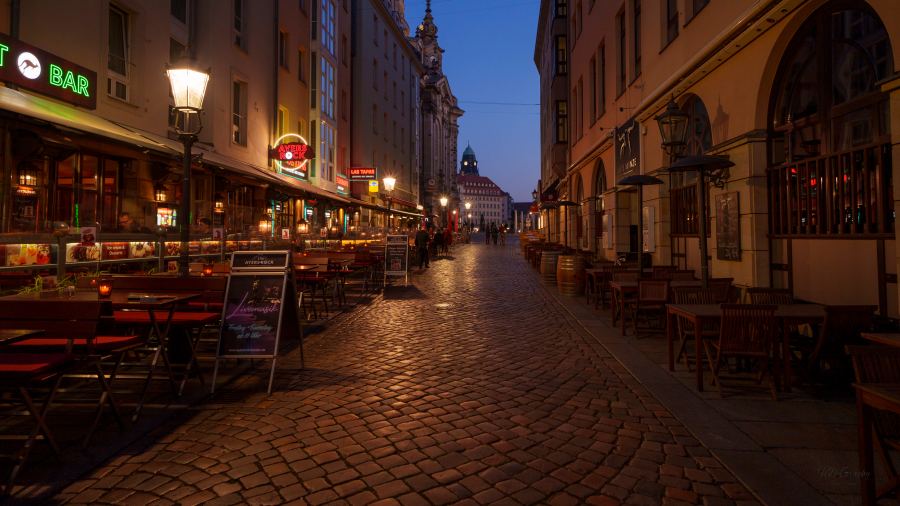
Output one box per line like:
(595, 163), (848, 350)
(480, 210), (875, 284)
(166, 62), (209, 277)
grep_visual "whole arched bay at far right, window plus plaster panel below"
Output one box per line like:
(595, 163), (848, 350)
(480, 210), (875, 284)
(767, 1), (897, 314)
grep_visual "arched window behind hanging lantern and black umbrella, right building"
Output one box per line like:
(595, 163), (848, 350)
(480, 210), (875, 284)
(669, 94), (712, 269)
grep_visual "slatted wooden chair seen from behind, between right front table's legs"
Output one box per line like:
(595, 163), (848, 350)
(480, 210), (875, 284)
(703, 304), (779, 400)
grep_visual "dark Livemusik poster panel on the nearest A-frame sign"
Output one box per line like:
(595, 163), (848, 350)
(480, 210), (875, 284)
(218, 273), (286, 358)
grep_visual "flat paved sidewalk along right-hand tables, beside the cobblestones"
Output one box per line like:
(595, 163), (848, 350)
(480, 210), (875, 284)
(534, 251), (859, 506)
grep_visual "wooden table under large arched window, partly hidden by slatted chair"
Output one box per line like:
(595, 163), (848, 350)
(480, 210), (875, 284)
(666, 304), (825, 392)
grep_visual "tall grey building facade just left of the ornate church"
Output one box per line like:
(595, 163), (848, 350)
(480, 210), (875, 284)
(351, 0), (424, 225)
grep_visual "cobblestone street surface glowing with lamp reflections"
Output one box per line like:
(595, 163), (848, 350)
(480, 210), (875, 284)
(56, 244), (754, 505)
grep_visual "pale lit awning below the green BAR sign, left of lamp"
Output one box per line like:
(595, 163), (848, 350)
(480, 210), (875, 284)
(0, 87), (181, 155)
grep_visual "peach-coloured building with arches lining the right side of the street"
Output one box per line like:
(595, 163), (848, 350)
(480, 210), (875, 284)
(542, 0), (900, 315)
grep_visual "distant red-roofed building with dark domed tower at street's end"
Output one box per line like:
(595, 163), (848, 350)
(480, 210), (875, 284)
(456, 146), (512, 227)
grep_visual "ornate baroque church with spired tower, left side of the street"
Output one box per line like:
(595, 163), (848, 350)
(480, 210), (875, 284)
(412, 0), (464, 224)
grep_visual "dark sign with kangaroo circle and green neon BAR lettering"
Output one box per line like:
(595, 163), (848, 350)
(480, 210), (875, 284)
(0, 34), (97, 109)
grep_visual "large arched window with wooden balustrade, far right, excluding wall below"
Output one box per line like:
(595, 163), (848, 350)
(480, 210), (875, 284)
(768, 4), (894, 238)
